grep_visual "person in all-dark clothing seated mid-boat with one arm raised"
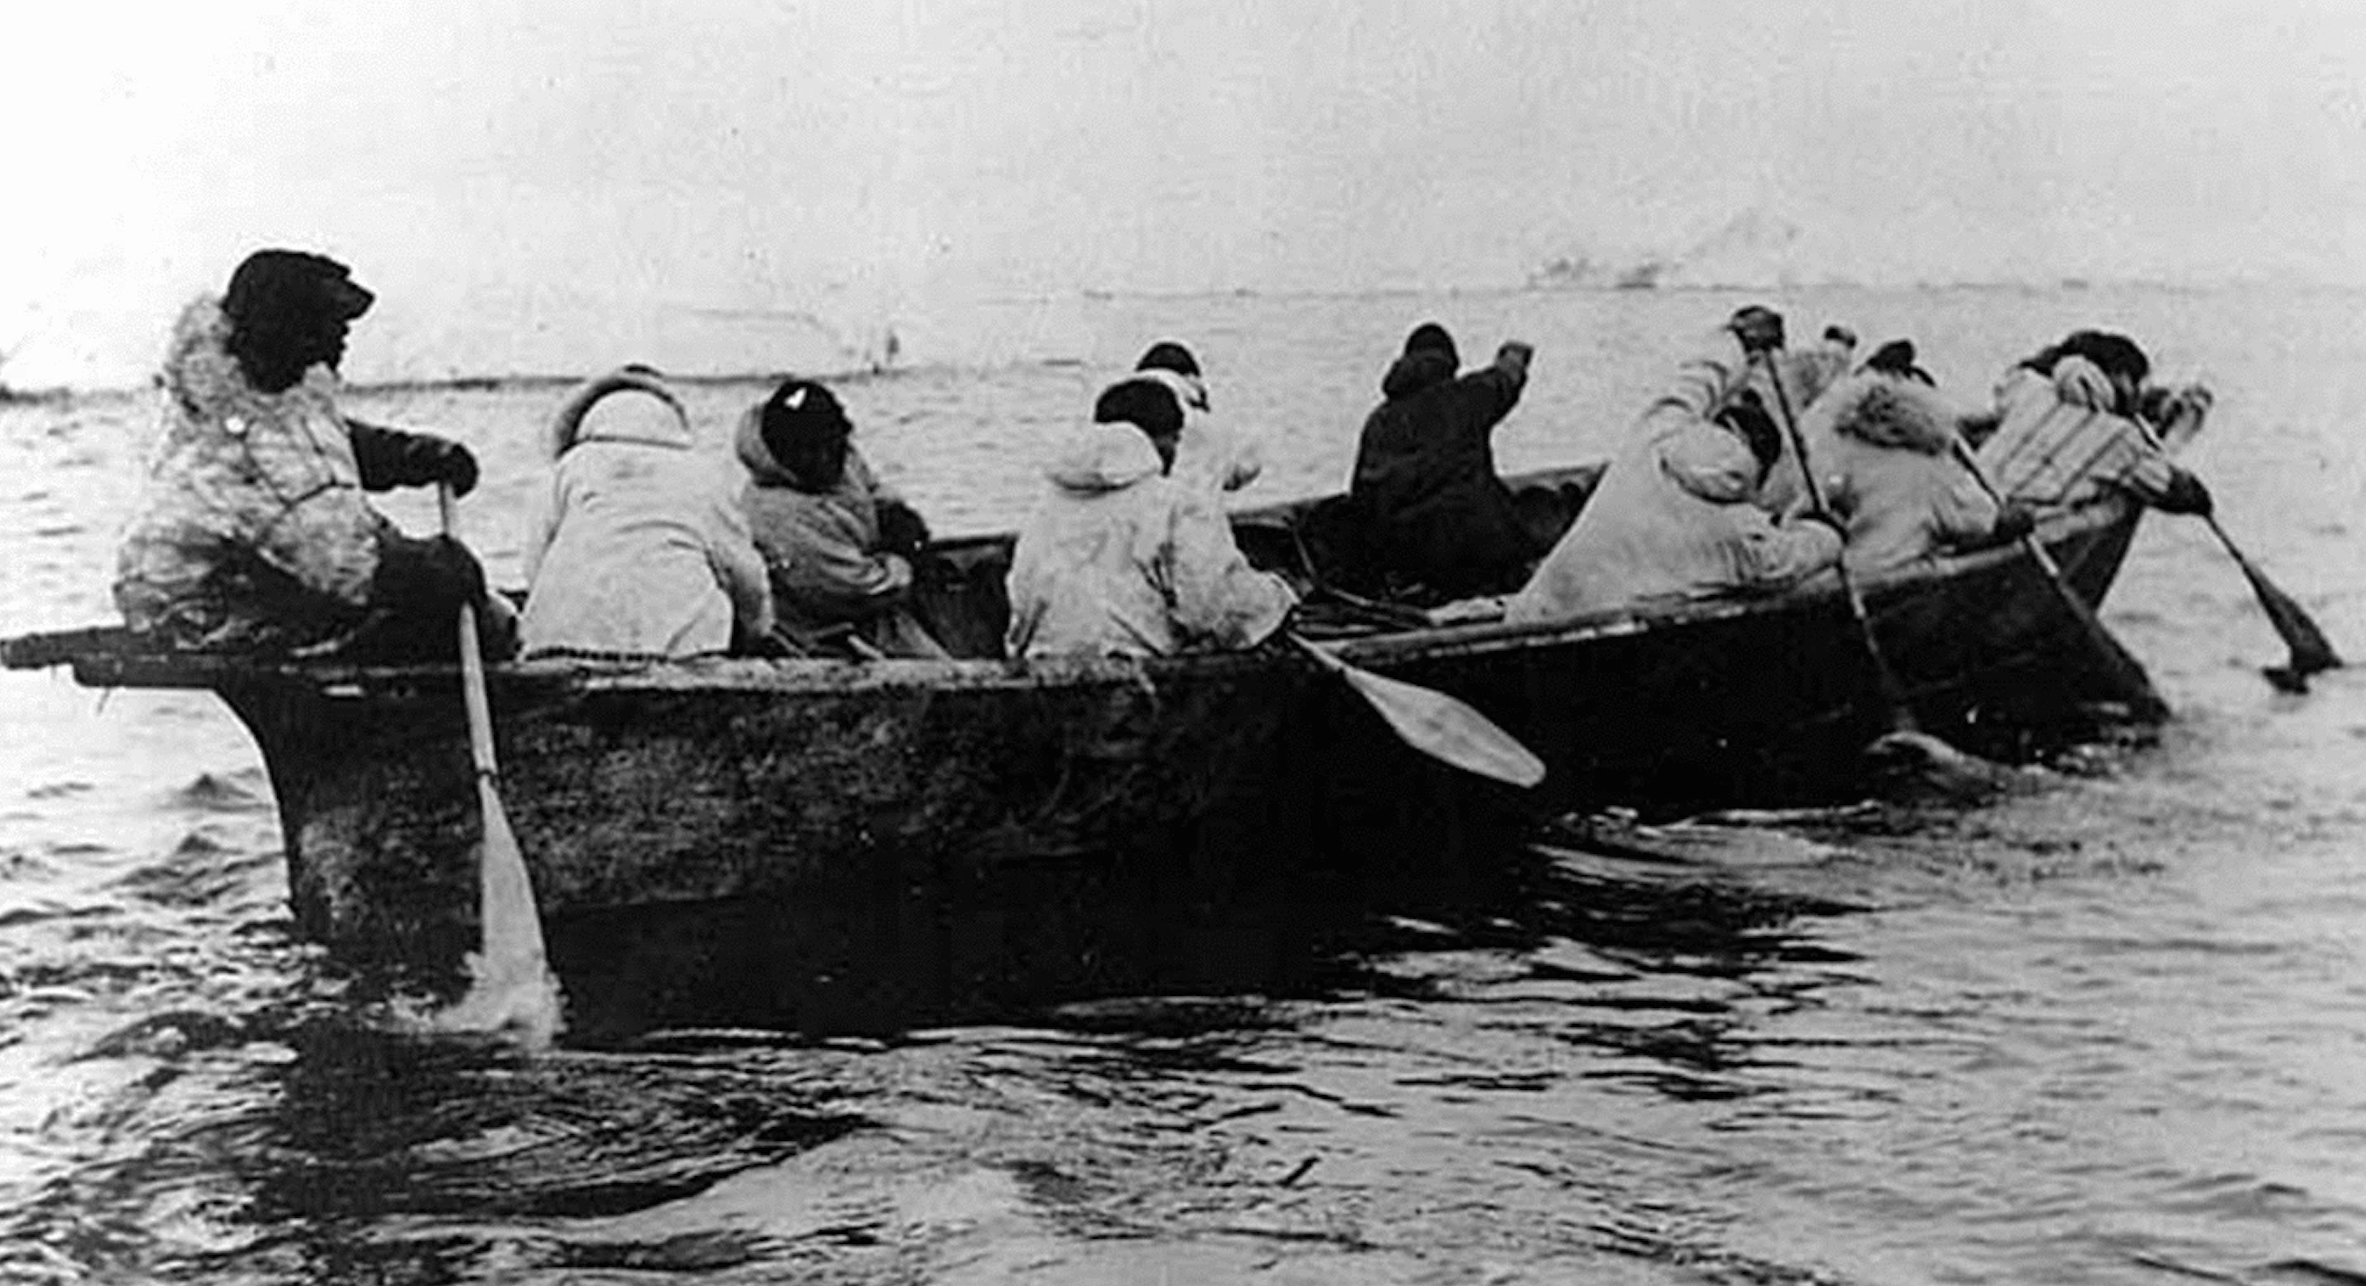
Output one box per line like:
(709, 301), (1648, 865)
(1349, 322), (1540, 598)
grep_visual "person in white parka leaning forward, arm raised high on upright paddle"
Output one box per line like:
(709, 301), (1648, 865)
(1505, 310), (1843, 624)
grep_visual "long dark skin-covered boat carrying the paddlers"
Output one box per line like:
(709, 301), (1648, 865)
(5, 468), (2139, 983)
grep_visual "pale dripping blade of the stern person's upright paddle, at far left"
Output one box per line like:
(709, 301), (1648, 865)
(438, 780), (561, 1047)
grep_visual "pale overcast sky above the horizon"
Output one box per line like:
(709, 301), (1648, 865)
(0, 0), (2366, 383)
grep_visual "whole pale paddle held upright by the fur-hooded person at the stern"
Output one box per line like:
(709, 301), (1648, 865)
(435, 482), (561, 1047)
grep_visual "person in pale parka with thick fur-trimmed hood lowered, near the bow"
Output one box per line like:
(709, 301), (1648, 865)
(1767, 340), (2030, 574)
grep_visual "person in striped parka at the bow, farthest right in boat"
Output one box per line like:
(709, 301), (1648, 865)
(1978, 331), (2210, 513)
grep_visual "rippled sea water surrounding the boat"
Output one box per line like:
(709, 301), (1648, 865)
(0, 291), (2366, 1284)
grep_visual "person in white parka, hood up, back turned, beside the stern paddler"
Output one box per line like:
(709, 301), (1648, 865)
(518, 366), (771, 660)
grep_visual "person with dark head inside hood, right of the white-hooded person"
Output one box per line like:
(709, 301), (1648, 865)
(736, 378), (946, 657)
